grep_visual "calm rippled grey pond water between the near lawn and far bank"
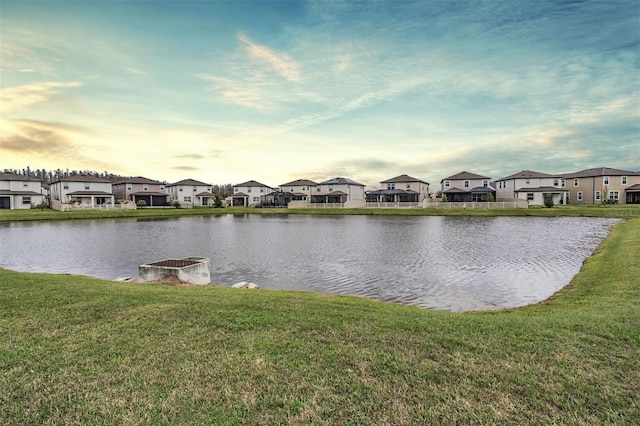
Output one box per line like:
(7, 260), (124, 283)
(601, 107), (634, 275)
(0, 215), (616, 311)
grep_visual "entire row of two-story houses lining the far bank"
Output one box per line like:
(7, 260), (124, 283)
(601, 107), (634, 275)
(0, 167), (640, 211)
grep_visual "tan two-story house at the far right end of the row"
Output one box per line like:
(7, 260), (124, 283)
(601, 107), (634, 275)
(562, 167), (640, 204)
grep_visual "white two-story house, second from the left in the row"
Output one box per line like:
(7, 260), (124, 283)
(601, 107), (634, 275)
(49, 175), (115, 210)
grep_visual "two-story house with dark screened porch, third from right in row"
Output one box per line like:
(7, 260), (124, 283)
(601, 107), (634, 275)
(440, 171), (496, 202)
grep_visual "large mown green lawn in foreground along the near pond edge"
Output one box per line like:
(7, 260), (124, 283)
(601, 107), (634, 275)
(0, 219), (640, 425)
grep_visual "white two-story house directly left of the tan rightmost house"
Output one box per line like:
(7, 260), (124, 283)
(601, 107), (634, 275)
(495, 170), (569, 206)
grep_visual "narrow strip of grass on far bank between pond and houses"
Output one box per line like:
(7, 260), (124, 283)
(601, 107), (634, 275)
(0, 205), (640, 223)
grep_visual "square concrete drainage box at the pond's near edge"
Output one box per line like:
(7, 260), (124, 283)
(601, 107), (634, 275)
(138, 257), (211, 285)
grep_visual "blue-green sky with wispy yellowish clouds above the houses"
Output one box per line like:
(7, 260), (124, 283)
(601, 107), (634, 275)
(0, 0), (640, 188)
